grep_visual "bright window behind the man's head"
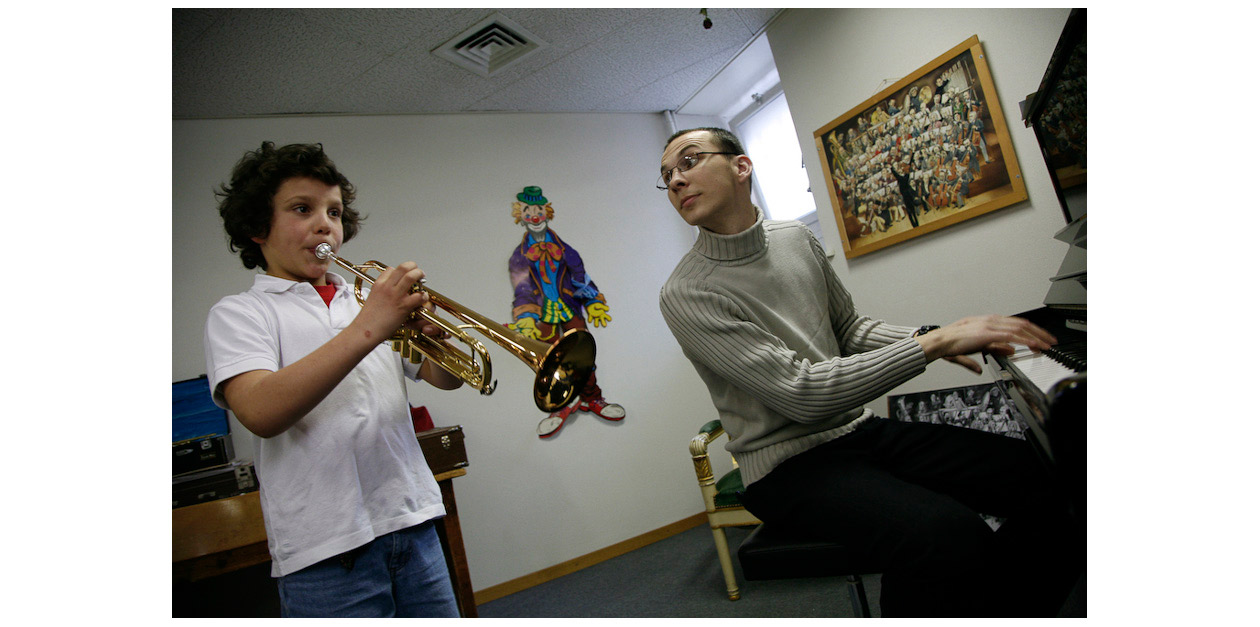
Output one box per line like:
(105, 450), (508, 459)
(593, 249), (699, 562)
(733, 91), (824, 242)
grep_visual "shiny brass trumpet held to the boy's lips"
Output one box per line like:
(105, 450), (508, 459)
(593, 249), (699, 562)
(315, 243), (595, 412)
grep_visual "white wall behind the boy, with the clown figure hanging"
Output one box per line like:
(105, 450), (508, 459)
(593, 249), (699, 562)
(171, 115), (716, 589)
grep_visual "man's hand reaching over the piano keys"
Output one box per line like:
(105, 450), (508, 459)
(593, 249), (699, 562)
(915, 315), (1058, 374)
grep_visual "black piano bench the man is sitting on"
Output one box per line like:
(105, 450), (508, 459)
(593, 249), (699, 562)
(736, 524), (881, 618)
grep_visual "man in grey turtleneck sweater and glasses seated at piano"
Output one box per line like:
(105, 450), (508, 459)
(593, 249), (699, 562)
(658, 128), (1084, 617)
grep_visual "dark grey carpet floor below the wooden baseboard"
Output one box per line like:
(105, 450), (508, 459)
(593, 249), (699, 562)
(478, 525), (879, 618)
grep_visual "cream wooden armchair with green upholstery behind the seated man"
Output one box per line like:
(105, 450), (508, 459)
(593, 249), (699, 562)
(690, 421), (761, 601)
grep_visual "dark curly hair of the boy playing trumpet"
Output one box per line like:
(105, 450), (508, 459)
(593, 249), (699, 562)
(214, 141), (365, 269)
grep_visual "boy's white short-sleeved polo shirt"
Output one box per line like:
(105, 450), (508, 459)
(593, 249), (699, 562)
(205, 273), (446, 577)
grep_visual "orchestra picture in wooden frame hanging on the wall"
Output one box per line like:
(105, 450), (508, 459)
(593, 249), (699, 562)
(814, 35), (1028, 258)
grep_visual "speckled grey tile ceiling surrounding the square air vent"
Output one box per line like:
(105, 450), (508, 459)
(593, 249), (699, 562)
(171, 9), (777, 118)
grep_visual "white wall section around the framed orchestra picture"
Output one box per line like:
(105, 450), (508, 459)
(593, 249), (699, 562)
(766, 9), (1068, 405)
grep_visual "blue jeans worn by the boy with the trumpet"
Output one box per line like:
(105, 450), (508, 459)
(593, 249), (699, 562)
(276, 520), (460, 618)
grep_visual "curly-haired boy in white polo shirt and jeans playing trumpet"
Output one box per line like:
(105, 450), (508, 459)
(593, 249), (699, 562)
(205, 142), (462, 617)
